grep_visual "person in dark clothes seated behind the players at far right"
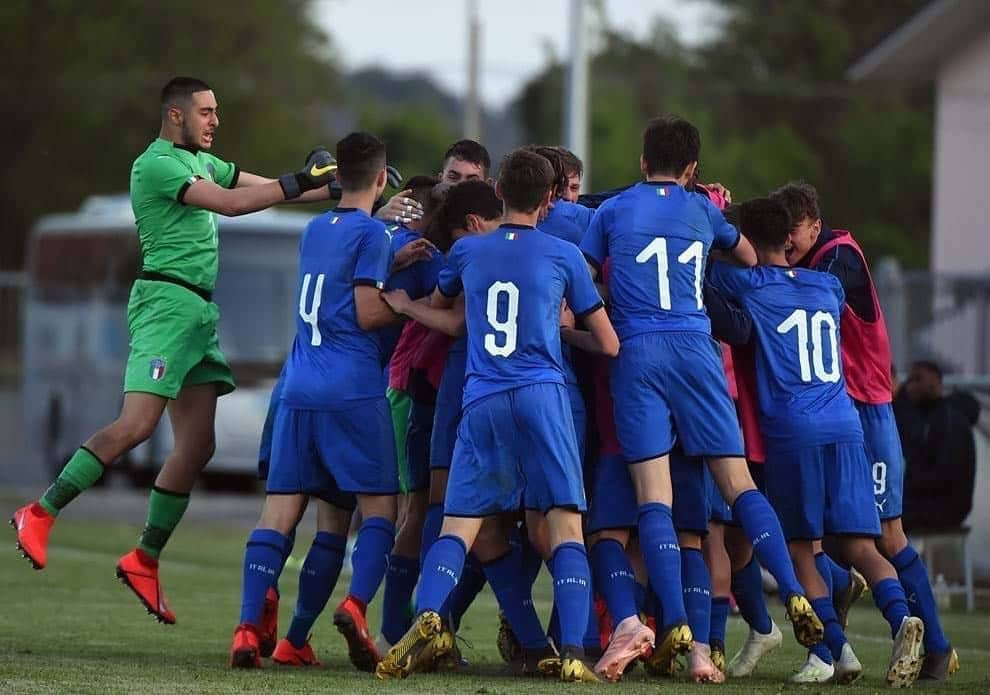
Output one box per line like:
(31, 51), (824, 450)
(894, 361), (980, 532)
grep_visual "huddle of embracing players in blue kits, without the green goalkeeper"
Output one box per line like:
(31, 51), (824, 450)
(231, 116), (958, 687)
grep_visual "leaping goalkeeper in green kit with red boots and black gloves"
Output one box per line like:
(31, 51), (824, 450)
(11, 77), (344, 624)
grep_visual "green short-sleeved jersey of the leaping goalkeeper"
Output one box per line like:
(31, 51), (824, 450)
(131, 138), (238, 291)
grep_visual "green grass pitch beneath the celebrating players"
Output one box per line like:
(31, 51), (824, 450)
(0, 512), (990, 695)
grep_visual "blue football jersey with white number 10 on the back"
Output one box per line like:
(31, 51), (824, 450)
(709, 263), (863, 446)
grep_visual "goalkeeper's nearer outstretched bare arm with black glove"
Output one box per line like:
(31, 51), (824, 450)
(184, 150), (337, 217)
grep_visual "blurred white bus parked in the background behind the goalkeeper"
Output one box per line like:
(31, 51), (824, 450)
(22, 195), (311, 484)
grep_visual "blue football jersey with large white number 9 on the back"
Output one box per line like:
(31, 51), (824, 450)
(437, 224), (602, 407)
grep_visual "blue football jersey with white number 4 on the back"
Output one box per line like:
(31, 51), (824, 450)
(282, 208), (392, 410)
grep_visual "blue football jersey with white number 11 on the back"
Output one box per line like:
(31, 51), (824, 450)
(581, 181), (739, 340)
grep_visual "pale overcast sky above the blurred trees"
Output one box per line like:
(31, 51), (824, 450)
(317, 0), (713, 108)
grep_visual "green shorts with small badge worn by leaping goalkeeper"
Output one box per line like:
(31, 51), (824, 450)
(124, 280), (234, 398)
